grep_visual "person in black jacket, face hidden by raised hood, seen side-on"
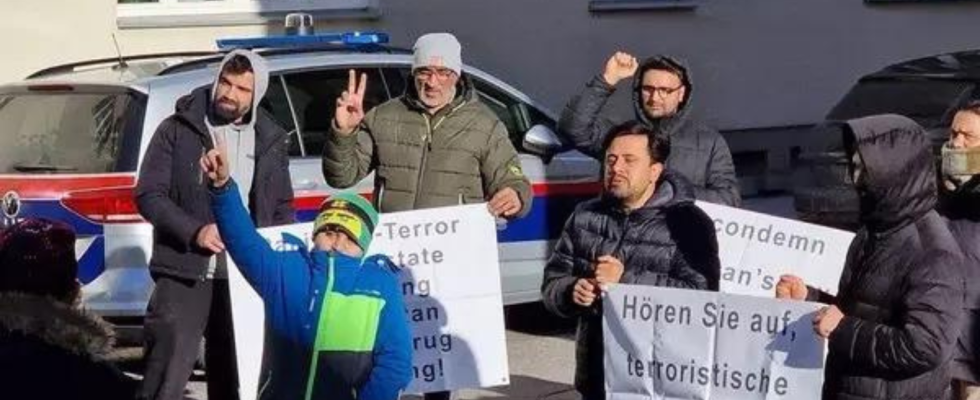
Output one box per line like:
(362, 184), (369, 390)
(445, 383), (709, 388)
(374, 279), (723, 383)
(776, 115), (963, 400)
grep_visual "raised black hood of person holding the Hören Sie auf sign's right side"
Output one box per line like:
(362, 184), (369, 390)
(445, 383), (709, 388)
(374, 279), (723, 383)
(844, 114), (938, 234)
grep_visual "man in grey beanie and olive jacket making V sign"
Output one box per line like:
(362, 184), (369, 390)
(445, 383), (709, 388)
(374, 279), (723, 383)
(323, 33), (532, 218)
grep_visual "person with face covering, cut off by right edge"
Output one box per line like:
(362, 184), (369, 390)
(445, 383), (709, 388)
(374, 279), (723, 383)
(939, 100), (980, 400)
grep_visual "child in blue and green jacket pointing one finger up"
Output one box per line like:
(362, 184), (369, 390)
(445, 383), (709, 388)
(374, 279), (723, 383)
(201, 150), (412, 400)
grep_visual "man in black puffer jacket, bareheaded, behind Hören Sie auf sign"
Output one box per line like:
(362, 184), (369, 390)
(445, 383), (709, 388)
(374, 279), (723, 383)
(541, 122), (721, 400)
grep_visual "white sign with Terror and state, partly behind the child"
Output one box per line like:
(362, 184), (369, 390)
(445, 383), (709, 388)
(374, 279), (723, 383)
(229, 204), (510, 398)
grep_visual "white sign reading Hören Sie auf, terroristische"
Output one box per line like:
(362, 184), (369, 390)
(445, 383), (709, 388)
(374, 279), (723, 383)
(603, 285), (824, 400)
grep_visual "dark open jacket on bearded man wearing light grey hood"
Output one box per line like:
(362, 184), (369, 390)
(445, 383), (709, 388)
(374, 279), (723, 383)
(136, 88), (295, 279)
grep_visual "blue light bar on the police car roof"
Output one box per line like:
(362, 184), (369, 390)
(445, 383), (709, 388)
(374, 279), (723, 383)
(217, 32), (389, 50)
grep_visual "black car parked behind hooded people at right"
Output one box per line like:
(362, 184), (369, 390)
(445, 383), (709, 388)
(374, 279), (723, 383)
(793, 50), (980, 230)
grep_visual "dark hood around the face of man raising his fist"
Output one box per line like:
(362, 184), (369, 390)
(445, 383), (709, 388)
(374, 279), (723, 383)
(633, 55), (694, 132)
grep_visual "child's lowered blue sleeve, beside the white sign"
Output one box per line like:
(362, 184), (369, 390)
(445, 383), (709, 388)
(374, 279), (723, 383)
(358, 262), (412, 400)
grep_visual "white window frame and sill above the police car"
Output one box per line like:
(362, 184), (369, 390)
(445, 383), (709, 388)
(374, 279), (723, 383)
(116, 0), (380, 28)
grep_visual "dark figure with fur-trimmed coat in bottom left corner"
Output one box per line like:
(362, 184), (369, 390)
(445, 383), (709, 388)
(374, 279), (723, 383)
(0, 218), (136, 400)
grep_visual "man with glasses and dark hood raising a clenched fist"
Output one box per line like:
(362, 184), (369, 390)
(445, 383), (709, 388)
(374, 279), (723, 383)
(558, 52), (742, 207)
